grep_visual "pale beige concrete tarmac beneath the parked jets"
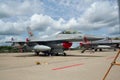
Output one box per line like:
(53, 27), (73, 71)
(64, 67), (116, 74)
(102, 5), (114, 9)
(0, 50), (120, 80)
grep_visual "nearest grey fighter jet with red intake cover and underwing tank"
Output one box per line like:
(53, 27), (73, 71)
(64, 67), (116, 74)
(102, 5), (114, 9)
(7, 27), (103, 56)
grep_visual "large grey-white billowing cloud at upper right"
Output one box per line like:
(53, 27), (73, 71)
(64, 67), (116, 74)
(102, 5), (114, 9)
(79, 1), (118, 29)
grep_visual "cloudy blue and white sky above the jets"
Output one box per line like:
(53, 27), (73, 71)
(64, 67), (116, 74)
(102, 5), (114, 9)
(0, 0), (119, 43)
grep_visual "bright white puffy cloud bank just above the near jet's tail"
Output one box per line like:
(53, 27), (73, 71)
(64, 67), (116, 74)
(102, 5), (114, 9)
(30, 14), (79, 31)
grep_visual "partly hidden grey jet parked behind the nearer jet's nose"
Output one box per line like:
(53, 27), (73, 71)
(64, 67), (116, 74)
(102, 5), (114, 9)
(80, 37), (120, 53)
